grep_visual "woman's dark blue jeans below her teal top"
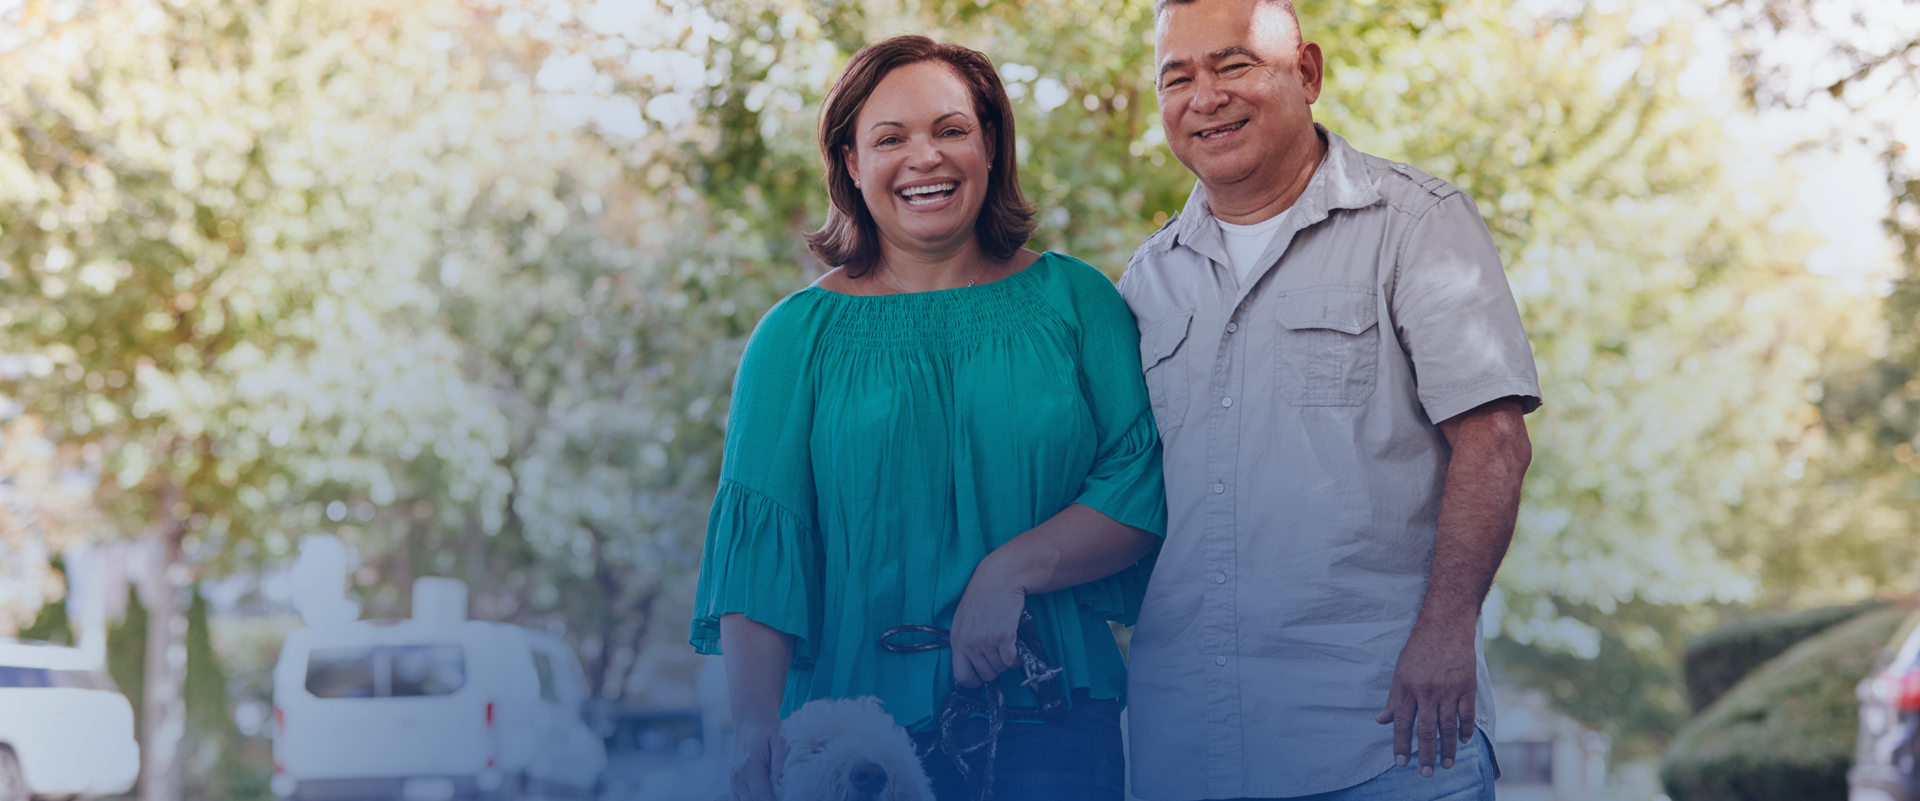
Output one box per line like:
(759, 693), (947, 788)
(914, 690), (1127, 801)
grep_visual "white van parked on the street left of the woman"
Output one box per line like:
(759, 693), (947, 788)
(273, 620), (607, 801)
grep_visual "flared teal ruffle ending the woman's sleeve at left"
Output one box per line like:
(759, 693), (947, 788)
(689, 482), (820, 665)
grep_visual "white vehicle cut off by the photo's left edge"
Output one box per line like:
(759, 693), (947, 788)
(0, 640), (140, 801)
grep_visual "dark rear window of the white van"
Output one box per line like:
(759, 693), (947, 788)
(307, 645), (467, 697)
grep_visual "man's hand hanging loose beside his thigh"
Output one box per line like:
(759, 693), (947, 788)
(1373, 624), (1478, 776)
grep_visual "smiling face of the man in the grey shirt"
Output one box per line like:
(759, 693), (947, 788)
(1154, 0), (1321, 186)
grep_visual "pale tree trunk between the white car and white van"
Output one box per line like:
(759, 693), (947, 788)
(140, 490), (190, 801)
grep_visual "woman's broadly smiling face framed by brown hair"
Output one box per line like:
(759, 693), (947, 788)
(843, 61), (993, 252)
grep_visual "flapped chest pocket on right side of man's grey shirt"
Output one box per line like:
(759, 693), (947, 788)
(1273, 286), (1380, 405)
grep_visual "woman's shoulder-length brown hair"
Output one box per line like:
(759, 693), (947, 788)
(806, 36), (1033, 279)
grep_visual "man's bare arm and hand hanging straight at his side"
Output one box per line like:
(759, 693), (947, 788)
(1375, 398), (1534, 776)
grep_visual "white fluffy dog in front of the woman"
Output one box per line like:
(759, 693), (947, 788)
(778, 695), (933, 801)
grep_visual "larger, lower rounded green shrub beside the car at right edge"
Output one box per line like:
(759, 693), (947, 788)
(1661, 607), (1908, 801)
